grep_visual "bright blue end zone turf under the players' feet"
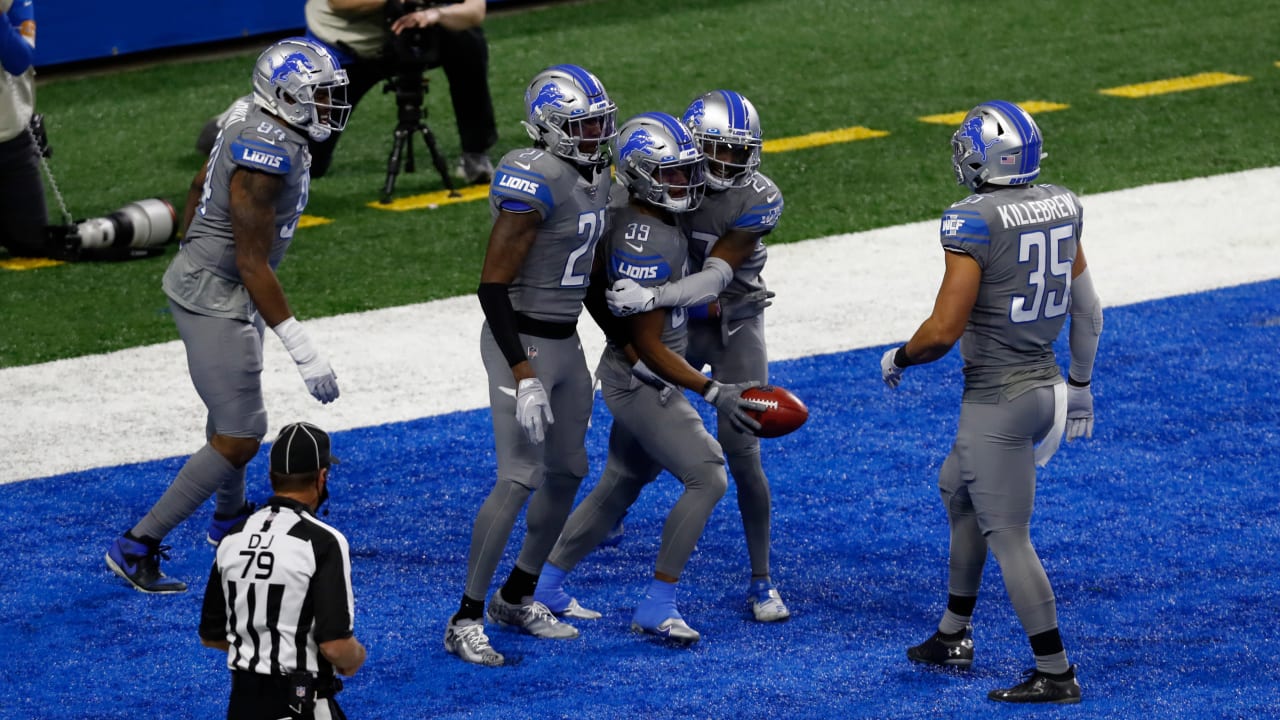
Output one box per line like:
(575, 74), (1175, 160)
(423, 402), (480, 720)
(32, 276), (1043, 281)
(0, 281), (1280, 720)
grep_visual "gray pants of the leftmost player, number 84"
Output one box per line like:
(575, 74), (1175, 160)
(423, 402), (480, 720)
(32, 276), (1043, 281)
(132, 300), (266, 539)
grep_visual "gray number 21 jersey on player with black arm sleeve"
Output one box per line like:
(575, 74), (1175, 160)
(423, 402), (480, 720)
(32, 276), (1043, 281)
(489, 149), (609, 323)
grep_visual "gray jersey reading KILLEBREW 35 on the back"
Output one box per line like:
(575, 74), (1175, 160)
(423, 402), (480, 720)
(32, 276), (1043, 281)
(940, 184), (1083, 402)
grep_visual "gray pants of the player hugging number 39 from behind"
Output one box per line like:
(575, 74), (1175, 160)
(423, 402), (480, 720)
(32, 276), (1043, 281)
(685, 310), (773, 578)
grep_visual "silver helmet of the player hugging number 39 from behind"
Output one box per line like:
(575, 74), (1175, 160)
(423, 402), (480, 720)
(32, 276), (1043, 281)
(682, 90), (763, 190)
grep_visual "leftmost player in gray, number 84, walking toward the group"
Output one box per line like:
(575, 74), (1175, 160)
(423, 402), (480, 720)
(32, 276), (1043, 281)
(106, 38), (351, 593)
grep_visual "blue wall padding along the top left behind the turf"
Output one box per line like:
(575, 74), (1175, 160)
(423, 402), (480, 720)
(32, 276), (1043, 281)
(36, 0), (524, 68)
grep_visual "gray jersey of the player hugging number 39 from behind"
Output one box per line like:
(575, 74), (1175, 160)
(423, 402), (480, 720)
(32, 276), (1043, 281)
(681, 173), (783, 297)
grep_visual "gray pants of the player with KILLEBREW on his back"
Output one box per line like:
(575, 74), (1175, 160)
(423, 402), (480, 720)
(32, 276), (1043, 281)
(938, 386), (1057, 637)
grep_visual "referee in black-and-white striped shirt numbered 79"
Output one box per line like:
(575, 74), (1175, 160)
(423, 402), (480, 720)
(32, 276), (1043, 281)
(200, 423), (365, 720)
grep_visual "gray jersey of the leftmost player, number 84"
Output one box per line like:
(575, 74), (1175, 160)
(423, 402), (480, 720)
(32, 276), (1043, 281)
(163, 96), (311, 319)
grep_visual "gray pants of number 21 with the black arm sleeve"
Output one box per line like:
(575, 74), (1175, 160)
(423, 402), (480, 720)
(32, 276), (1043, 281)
(465, 323), (595, 601)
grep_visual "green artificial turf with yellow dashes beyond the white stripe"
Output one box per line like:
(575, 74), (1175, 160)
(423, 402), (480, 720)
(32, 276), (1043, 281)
(0, 0), (1280, 366)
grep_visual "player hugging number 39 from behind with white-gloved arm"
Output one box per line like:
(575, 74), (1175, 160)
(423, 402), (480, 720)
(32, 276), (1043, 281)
(607, 90), (791, 623)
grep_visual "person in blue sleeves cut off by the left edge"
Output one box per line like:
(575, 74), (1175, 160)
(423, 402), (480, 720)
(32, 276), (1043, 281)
(0, 0), (49, 256)
